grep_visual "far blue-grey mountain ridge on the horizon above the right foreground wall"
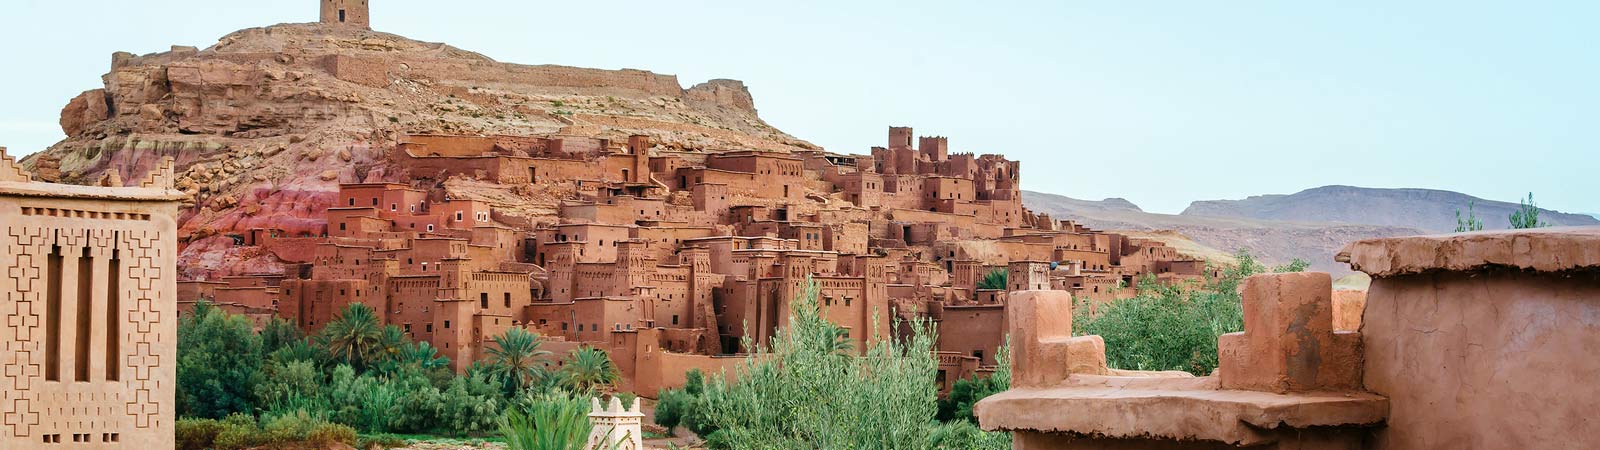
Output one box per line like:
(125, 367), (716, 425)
(1182, 186), (1600, 232)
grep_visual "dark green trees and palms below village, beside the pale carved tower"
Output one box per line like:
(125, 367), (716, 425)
(178, 301), (619, 438)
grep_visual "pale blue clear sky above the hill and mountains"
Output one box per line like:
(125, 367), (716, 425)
(0, 0), (1600, 213)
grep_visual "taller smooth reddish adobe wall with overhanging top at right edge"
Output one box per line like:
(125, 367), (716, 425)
(1346, 227), (1600, 448)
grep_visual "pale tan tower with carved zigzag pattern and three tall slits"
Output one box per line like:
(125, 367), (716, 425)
(0, 149), (184, 450)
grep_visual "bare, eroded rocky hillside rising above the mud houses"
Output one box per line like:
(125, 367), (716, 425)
(24, 24), (814, 275)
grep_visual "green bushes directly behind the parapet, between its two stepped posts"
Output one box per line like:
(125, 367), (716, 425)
(1072, 250), (1307, 375)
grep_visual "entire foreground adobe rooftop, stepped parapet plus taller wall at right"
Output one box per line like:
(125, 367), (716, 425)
(976, 227), (1600, 448)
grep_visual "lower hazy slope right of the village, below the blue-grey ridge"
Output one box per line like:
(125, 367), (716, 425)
(1022, 191), (1424, 275)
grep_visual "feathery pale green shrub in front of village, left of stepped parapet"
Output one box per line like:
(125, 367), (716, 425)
(656, 278), (1011, 448)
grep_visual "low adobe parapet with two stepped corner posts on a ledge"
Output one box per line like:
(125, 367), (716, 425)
(974, 274), (1389, 448)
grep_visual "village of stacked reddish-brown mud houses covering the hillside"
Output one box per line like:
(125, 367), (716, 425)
(179, 128), (1206, 392)
